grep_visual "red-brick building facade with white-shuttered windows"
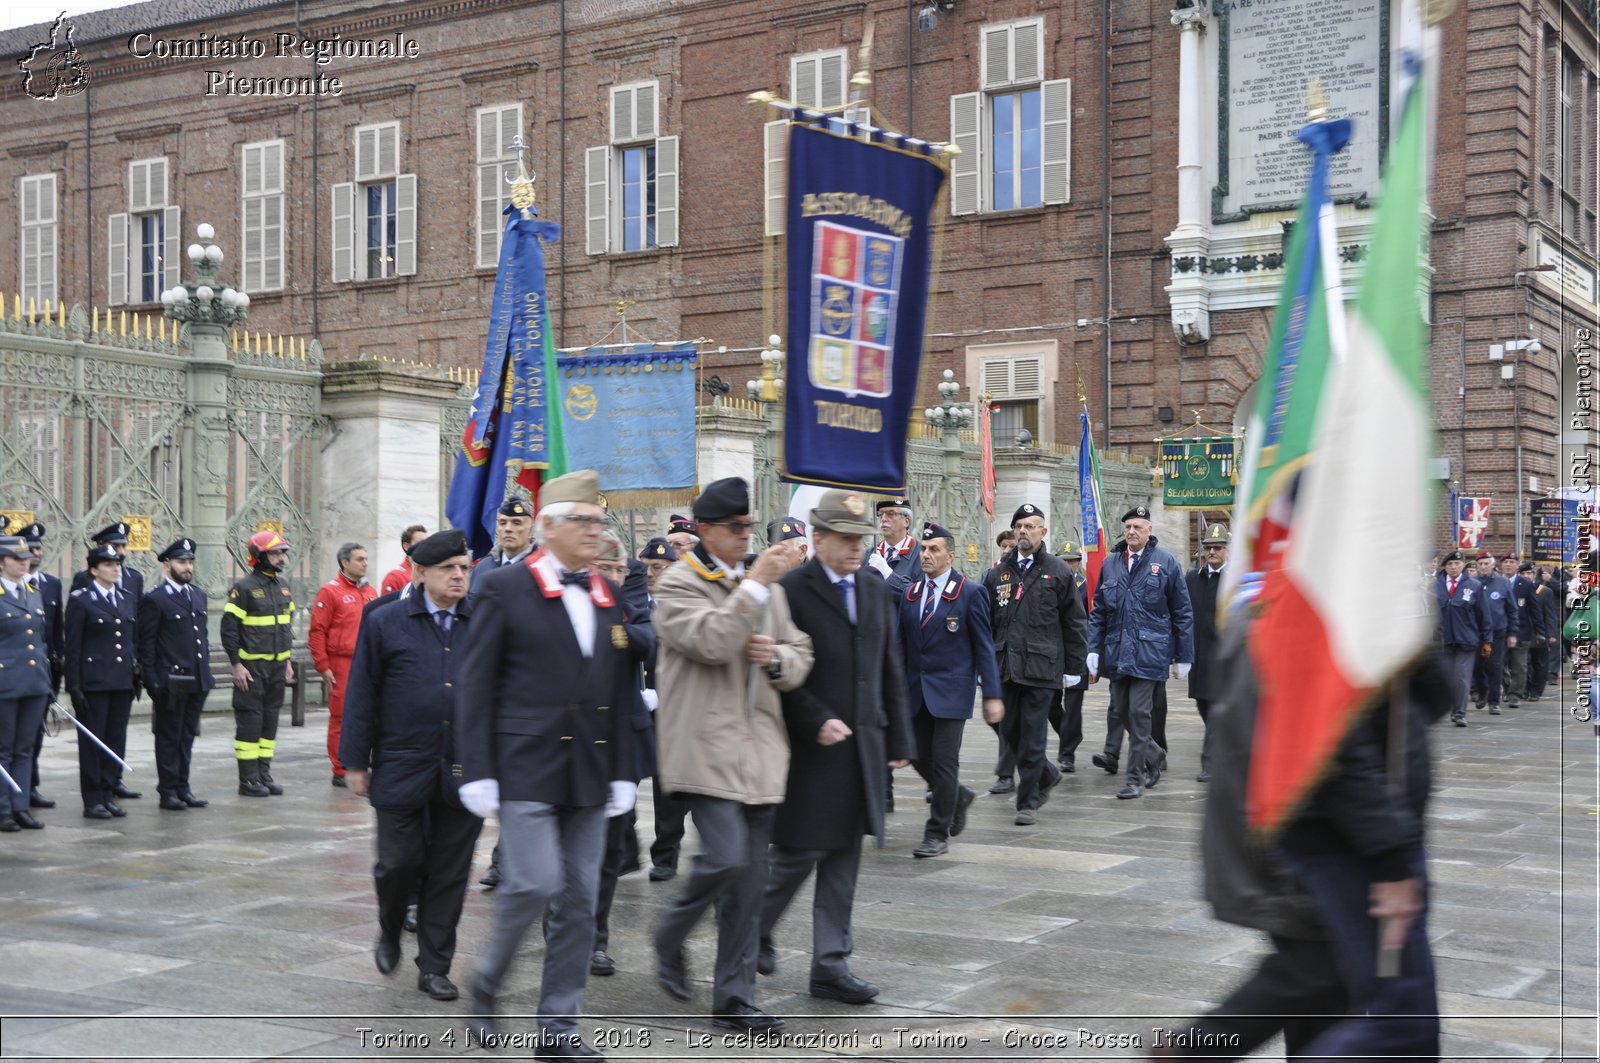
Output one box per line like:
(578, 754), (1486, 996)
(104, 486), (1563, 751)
(0, 0), (1597, 557)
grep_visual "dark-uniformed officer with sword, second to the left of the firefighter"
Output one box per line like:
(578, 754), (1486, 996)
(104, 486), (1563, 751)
(66, 546), (138, 820)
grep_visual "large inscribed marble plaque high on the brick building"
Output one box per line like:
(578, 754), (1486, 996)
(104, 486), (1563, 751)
(1218, 0), (1387, 216)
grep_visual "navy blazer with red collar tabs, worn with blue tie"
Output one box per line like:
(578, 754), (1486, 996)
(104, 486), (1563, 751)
(899, 572), (1000, 720)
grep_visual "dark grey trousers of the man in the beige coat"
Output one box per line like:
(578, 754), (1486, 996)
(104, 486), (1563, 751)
(656, 794), (778, 1012)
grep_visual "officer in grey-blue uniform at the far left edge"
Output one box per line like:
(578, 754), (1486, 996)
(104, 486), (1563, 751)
(0, 535), (50, 832)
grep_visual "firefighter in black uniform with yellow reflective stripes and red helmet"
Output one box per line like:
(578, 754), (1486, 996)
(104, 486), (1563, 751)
(222, 532), (294, 797)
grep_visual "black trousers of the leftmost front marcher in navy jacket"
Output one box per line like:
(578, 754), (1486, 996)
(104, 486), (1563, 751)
(373, 800), (483, 975)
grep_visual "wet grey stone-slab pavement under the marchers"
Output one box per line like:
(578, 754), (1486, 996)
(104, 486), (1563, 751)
(0, 684), (1600, 1060)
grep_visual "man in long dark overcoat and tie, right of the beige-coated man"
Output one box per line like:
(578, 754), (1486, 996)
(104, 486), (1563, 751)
(757, 490), (915, 1004)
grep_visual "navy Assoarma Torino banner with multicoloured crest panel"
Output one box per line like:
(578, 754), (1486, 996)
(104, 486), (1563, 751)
(779, 123), (946, 495)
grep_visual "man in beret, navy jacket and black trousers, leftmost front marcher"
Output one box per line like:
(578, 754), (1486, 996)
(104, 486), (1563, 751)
(339, 530), (483, 1001)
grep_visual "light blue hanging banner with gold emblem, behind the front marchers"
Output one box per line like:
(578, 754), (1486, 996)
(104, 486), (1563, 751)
(555, 343), (699, 507)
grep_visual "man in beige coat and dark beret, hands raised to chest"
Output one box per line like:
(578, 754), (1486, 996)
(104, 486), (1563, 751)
(654, 477), (811, 1033)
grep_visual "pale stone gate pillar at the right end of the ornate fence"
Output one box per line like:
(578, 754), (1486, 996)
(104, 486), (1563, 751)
(315, 362), (459, 583)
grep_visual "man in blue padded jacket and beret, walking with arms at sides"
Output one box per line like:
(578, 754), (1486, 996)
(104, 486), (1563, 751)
(1088, 506), (1195, 800)
